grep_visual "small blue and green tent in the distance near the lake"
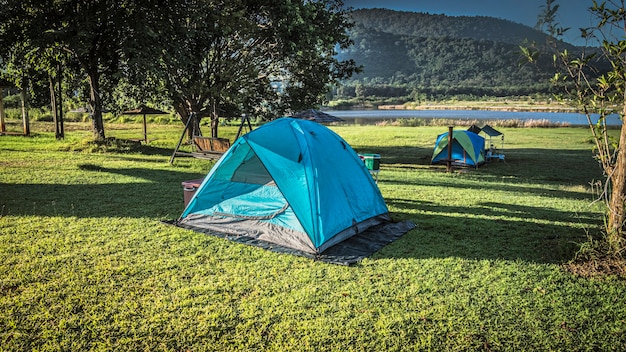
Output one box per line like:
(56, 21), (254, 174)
(431, 130), (485, 167)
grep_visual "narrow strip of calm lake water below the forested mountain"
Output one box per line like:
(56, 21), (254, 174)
(326, 110), (621, 126)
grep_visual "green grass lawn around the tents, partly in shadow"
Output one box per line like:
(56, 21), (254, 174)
(0, 123), (626, 351)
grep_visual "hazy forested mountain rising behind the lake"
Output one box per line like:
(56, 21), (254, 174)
(337, 9), (576, 99)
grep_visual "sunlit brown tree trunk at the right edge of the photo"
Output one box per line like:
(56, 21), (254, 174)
(607, 92), (626, 252)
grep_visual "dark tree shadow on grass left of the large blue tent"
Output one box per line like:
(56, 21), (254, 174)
(0, 164), (204, 219)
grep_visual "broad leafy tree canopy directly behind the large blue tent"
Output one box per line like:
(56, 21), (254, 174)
(141, 0), (356, 136)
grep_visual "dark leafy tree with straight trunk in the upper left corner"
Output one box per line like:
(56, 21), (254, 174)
(0, 0), (149, 139)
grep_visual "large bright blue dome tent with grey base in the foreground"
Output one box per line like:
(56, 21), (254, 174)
(178, 118), (391, 254)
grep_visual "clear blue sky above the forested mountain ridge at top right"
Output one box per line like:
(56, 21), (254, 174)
(344, 0), (601, 43)
